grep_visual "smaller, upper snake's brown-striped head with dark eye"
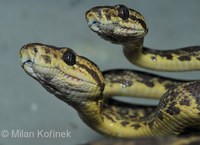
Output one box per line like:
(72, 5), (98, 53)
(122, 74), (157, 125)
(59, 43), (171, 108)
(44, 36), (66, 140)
(85, 5), (148, 44)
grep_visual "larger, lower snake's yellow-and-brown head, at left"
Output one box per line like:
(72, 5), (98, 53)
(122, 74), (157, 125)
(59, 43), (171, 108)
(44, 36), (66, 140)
(20, 43), (104, 102)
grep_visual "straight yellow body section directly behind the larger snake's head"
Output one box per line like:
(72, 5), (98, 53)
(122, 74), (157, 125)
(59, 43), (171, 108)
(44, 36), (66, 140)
(103, 69), (184, 99)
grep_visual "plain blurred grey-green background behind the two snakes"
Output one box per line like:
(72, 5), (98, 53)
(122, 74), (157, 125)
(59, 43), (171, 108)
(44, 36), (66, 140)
(0, 0), (200, 145)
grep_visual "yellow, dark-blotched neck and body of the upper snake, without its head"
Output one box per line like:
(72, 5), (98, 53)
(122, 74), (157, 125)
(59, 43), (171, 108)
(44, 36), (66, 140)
(122, 38), (200, 71)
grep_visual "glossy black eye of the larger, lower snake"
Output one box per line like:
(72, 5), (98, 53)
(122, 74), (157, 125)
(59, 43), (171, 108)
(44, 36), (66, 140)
(62, 50), (76, 66)
